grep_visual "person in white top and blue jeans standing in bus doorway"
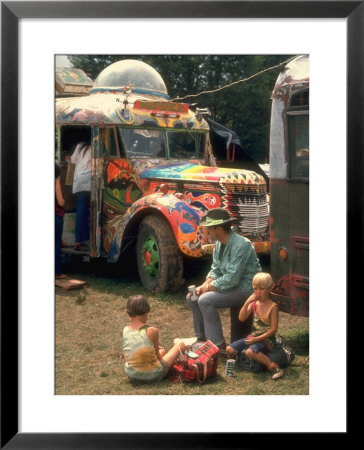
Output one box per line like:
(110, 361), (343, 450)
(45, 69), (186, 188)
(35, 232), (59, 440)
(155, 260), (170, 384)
(71, 135), (91, 250)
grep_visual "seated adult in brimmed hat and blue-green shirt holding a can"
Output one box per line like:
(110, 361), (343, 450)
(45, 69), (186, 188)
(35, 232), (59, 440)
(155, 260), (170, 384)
(186, 208), (262, 352)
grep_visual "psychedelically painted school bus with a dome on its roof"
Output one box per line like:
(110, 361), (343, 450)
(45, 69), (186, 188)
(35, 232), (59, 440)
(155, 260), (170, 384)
(55, 60), (270, 292)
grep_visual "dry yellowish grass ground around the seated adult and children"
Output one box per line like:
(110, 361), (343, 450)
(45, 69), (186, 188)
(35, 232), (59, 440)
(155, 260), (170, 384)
(55, 258), (309, 395)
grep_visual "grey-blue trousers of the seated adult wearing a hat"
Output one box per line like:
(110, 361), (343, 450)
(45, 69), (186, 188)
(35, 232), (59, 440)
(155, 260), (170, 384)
(186, 287), (251, 345)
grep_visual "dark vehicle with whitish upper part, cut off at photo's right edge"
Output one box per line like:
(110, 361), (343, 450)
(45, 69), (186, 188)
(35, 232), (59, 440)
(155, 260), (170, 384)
(269, 55), (310, 316)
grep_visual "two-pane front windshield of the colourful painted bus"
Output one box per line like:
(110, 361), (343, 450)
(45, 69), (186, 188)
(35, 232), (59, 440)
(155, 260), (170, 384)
(119, 127), (205, 160)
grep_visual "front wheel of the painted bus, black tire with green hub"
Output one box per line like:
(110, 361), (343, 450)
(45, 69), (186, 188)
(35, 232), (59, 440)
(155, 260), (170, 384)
(136, 216), (183, 293)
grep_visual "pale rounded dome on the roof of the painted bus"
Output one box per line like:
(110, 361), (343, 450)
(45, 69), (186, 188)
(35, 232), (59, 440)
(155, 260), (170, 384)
(91, 59), (168, 98)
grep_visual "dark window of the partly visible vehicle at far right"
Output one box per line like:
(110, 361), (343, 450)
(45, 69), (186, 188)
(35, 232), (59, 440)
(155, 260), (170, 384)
(287, 91), (310, 178)
